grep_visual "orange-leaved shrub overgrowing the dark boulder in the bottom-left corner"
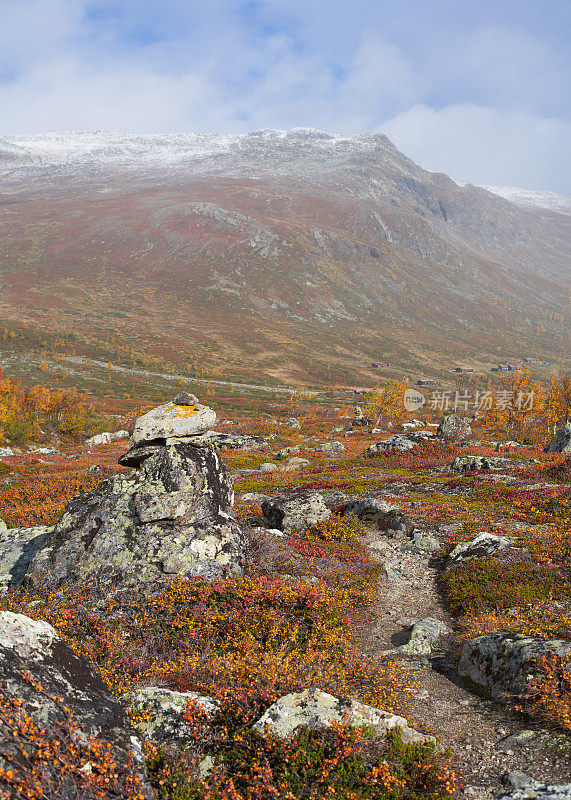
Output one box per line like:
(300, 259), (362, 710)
(0, 677), (145, 800)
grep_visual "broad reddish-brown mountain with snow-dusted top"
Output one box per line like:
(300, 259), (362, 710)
(0, 130), (570, 382)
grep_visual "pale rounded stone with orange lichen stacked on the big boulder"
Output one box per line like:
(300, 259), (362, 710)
(132, 403), (216, 444)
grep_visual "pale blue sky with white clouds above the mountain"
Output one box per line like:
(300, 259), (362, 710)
(0, 0), (571, 194)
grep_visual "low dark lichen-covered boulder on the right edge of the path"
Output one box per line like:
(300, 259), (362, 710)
(458, 633), (571, 703)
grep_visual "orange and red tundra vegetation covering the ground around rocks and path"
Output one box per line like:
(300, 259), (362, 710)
(0, 370), (571, 800)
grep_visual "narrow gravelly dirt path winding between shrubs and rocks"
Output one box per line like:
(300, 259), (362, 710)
(358, 527), (571, 800)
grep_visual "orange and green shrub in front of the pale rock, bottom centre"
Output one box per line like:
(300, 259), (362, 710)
(148, 724), (456, 800)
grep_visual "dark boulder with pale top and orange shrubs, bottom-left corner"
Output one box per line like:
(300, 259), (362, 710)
(0, 611), (150, 798)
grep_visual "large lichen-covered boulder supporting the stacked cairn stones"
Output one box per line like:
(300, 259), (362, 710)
(26, 442), (243, 587)
